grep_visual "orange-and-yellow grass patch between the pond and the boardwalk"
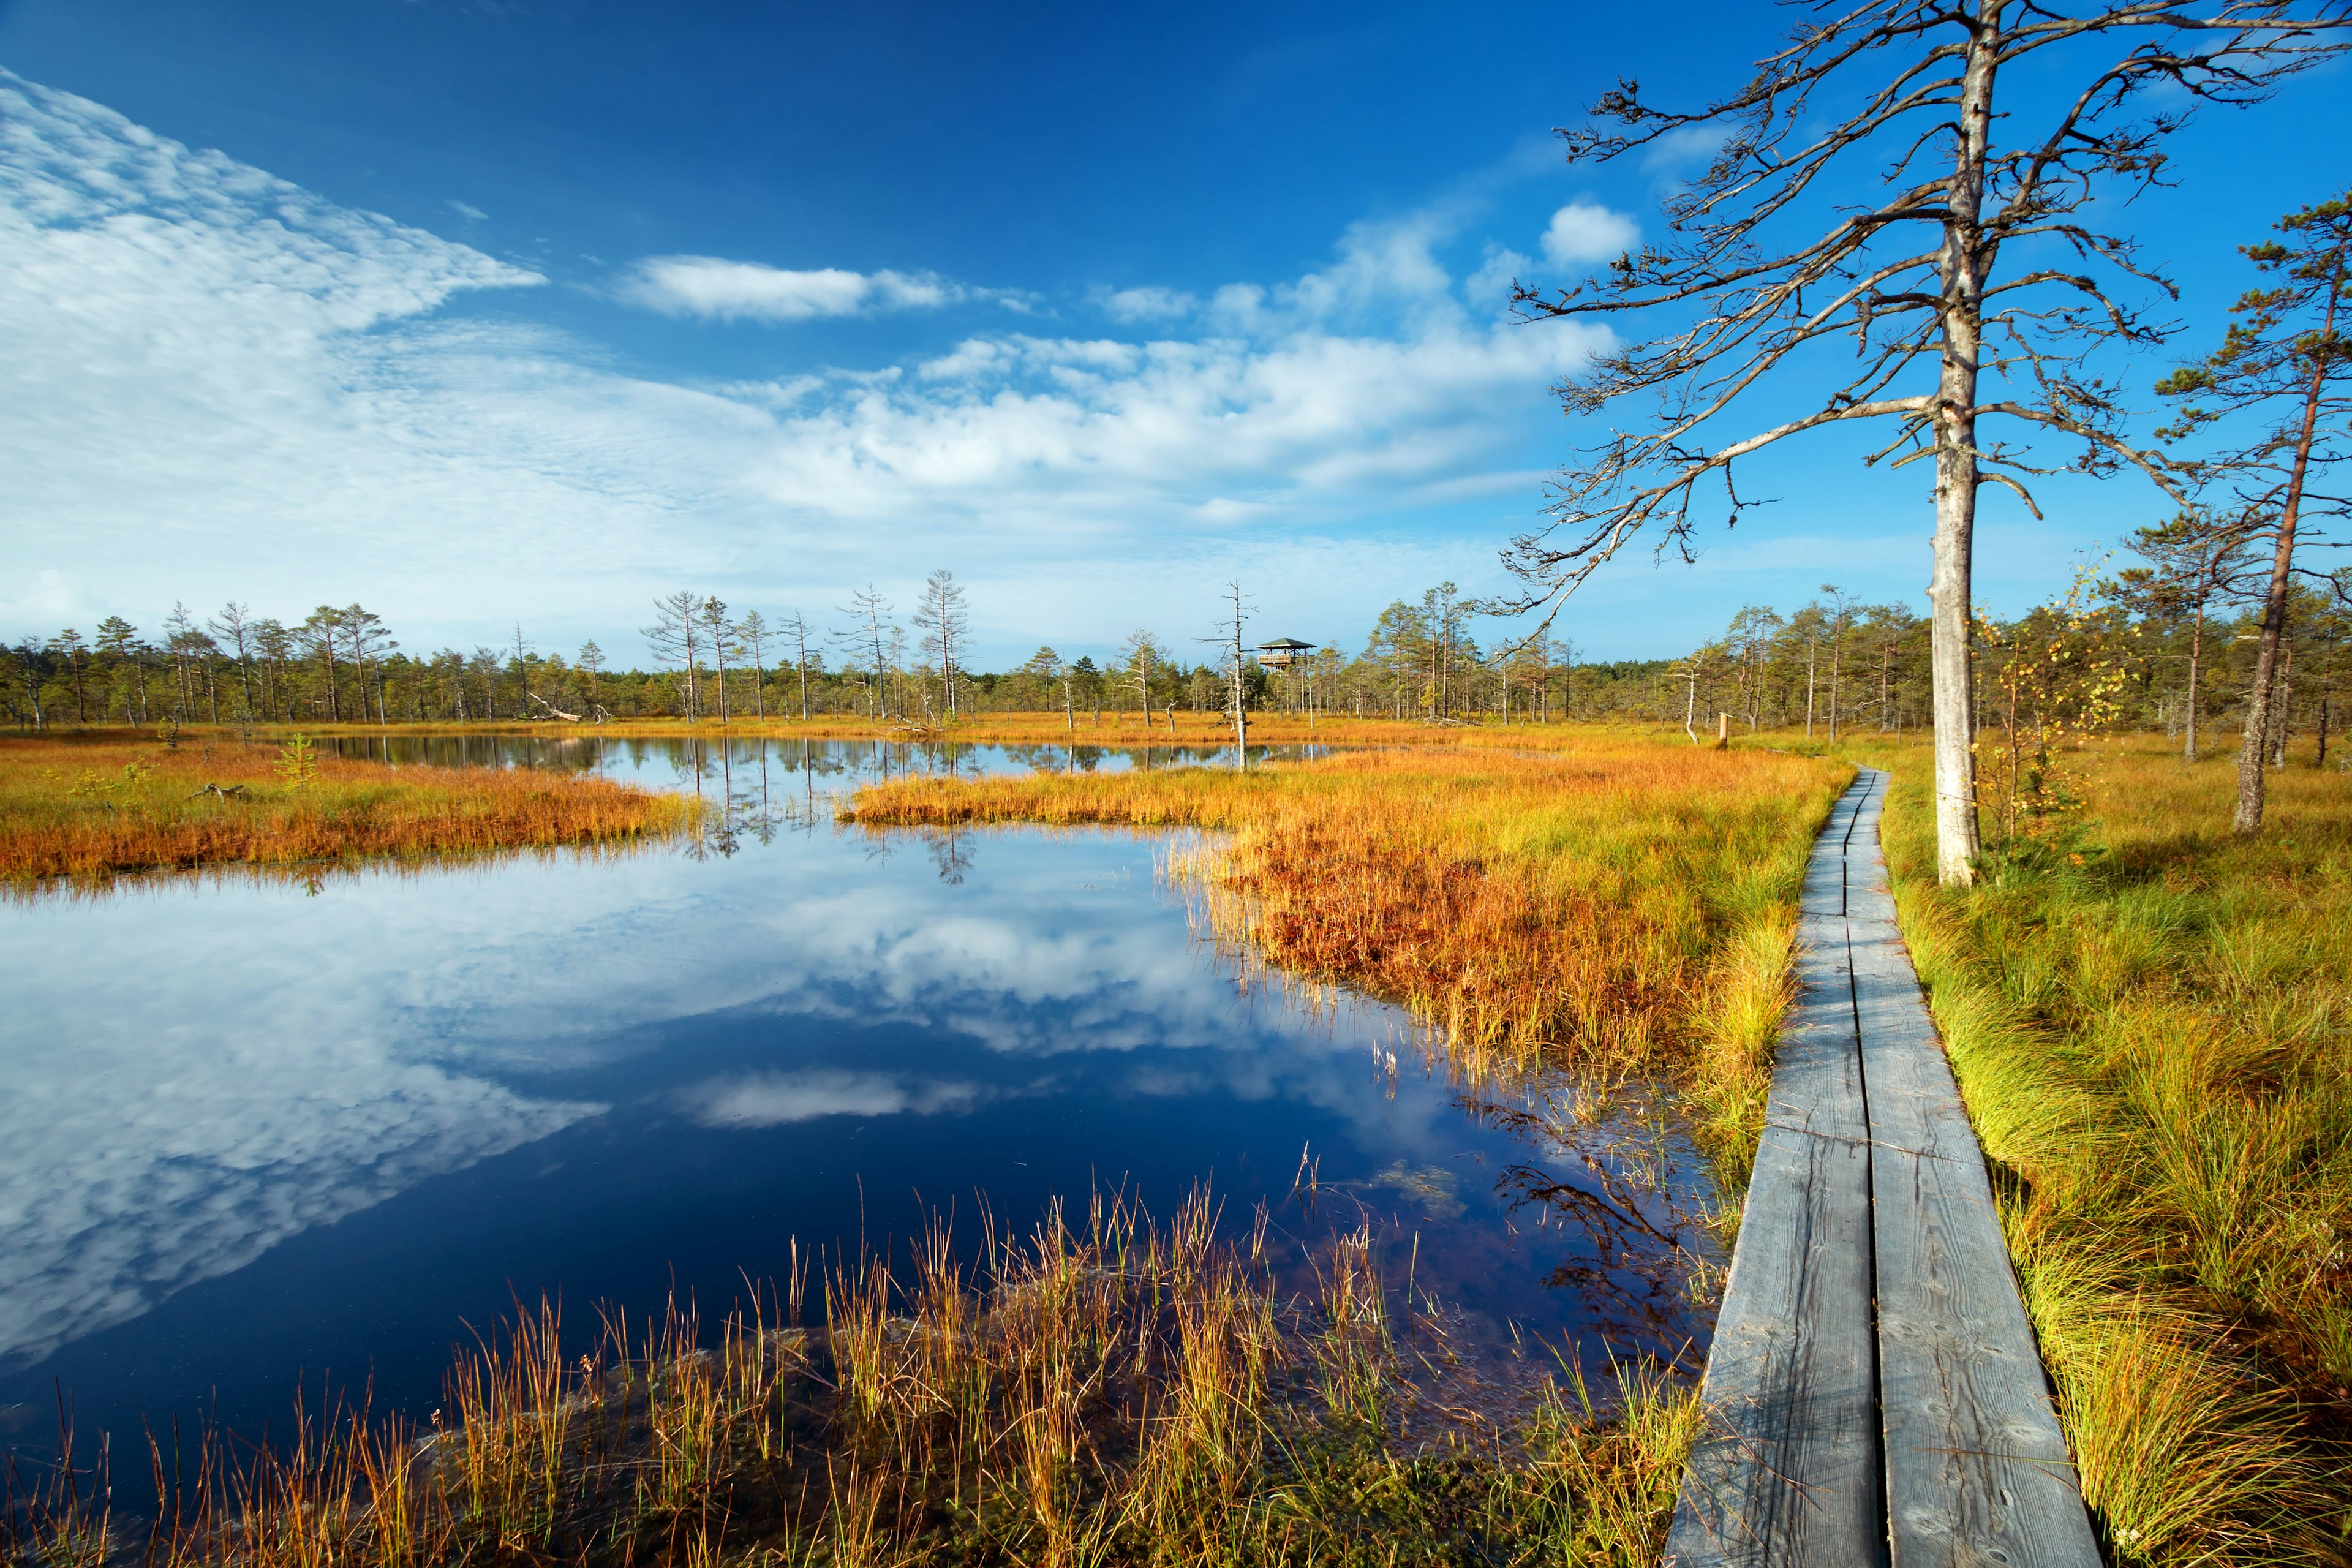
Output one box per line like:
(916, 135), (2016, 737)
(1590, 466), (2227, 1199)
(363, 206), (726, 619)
(845, 729), (1851, 1166)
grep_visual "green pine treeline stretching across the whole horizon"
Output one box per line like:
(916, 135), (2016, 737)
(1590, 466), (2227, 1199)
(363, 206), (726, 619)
(0, 554), (2352, 762)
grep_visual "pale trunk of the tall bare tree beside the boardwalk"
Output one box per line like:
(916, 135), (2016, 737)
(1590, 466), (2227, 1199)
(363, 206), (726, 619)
(1926, 0), (2002, 886)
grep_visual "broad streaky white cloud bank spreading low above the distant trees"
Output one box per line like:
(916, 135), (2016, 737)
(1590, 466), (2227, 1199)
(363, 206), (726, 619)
(0, 75), (1607, 658)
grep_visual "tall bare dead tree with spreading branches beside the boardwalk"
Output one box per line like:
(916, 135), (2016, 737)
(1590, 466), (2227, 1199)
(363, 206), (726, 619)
(1506, 0), (2352, 884)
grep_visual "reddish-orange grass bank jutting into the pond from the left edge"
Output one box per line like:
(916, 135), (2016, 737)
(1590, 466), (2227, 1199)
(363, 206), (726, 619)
(0, 738), (694, 881)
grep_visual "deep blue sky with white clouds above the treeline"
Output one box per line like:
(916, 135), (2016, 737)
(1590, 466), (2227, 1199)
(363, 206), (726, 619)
(0, 0), (2352, 663)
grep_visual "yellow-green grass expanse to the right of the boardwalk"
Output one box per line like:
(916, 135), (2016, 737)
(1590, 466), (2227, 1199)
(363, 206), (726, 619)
(1889, 743), (2352, 1563)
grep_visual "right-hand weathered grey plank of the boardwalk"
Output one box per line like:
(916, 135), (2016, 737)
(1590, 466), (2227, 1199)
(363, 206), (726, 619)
(1846, 766), (2100, 1568)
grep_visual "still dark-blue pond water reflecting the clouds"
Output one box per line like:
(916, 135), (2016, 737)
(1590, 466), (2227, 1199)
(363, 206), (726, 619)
(0, 741), (1708, 1450)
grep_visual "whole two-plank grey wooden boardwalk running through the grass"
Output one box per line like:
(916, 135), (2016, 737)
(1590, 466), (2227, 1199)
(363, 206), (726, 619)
(1665, 769), (2100, 1568)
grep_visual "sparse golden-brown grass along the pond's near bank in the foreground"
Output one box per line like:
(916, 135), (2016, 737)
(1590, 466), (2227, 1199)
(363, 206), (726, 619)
(0, 1199), (1698, 1568)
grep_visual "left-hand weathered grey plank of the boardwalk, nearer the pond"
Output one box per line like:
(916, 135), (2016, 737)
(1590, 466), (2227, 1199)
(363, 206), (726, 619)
(1665, 785), (1887, 1568)
